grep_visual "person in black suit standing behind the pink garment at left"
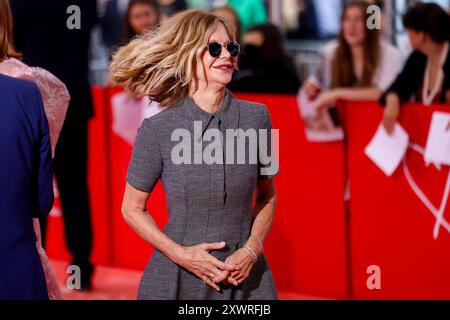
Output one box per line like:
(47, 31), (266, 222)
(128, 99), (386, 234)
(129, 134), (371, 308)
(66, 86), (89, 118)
(11, 0), (97, 289)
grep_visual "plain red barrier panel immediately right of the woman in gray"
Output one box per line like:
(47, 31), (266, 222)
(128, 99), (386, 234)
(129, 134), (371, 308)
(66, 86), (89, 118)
(234, 94), (347, 298)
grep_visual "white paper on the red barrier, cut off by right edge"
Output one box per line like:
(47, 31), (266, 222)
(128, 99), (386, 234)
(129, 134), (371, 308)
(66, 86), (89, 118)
(424, 112), (450, 166)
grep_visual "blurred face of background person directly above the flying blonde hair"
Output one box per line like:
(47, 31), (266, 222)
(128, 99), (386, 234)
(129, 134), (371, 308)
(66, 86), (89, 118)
(124, 0), (161, 43)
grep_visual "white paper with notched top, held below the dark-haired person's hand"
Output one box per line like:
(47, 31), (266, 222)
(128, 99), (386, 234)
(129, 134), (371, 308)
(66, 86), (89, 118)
(364, 123), (409, 177)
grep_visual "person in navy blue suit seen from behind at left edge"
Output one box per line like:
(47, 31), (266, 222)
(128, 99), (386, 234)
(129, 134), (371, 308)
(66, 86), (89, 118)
(0, 74), (53, 300)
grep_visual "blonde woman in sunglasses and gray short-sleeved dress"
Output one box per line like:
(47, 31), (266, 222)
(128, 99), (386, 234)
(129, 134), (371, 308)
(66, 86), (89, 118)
(110, 10), (278, 300)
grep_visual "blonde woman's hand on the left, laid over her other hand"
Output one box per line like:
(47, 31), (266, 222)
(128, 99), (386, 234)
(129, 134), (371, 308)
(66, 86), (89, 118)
(178, 242), (240, 291)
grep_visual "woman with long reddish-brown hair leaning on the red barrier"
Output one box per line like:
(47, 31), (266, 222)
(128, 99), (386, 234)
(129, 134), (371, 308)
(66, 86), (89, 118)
(302, 1), (402, 117)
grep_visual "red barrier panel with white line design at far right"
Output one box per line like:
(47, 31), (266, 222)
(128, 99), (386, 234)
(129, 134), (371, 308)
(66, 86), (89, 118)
(345, 103), (450, 299)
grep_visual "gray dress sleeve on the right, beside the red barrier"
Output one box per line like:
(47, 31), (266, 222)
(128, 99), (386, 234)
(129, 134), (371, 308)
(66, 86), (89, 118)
(258, 106), (279, 180)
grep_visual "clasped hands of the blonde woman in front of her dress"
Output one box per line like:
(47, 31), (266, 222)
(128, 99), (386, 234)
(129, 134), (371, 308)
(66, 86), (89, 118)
(178, 239), (262, 292)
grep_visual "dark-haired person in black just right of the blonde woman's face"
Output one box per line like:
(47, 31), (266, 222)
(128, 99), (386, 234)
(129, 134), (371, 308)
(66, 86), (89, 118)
(228, 24), (300, 93)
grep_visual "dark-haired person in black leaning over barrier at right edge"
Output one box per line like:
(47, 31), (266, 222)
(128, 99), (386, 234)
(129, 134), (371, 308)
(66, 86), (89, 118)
(380, 3), (450, 133)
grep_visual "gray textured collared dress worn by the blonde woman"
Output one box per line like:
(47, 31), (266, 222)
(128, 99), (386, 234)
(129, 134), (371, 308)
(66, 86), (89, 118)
(127, 90), (277, 300)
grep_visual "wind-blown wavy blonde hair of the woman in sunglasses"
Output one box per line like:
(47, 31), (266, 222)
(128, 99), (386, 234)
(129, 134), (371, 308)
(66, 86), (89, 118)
(110, 9), (236, 107)
